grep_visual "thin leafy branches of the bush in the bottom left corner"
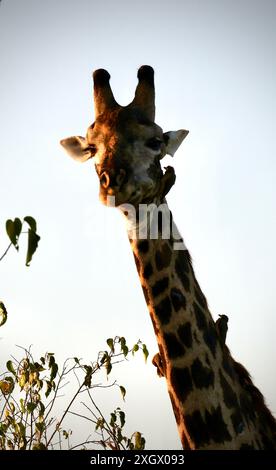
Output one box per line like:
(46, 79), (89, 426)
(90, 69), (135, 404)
(0, 336), (148, 450)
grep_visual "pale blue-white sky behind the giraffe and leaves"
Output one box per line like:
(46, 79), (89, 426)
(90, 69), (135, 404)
(0, 0), (276, 449)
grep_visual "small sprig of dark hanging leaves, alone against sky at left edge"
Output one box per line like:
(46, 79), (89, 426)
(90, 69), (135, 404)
(0, 215), (40, 266)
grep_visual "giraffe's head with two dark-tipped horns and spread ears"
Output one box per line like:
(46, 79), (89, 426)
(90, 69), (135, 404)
(61, 65), (188, 206)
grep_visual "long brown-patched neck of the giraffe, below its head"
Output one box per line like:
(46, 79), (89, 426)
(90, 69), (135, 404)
(125, 198), (276, 449)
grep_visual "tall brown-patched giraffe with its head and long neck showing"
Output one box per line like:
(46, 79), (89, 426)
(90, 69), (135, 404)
(61, 65), (276, 450)
